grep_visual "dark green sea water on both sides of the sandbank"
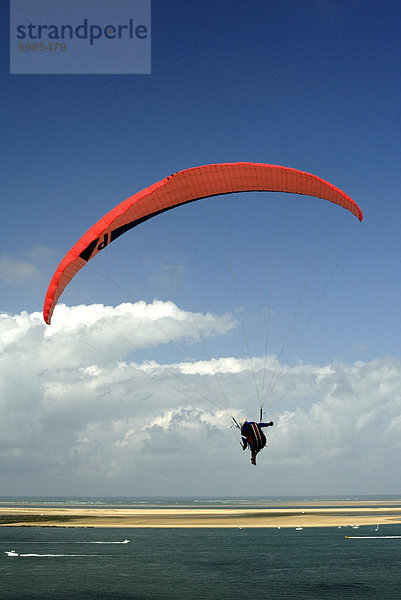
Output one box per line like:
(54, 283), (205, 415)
(0, 497), (401, 600)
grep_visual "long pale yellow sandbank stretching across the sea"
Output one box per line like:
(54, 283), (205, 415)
(0, 501), (401, 528)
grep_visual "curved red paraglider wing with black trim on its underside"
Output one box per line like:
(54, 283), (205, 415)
(43, 163), (362, 324)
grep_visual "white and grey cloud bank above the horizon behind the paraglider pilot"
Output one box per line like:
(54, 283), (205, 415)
(0, 301), (401, 496)
